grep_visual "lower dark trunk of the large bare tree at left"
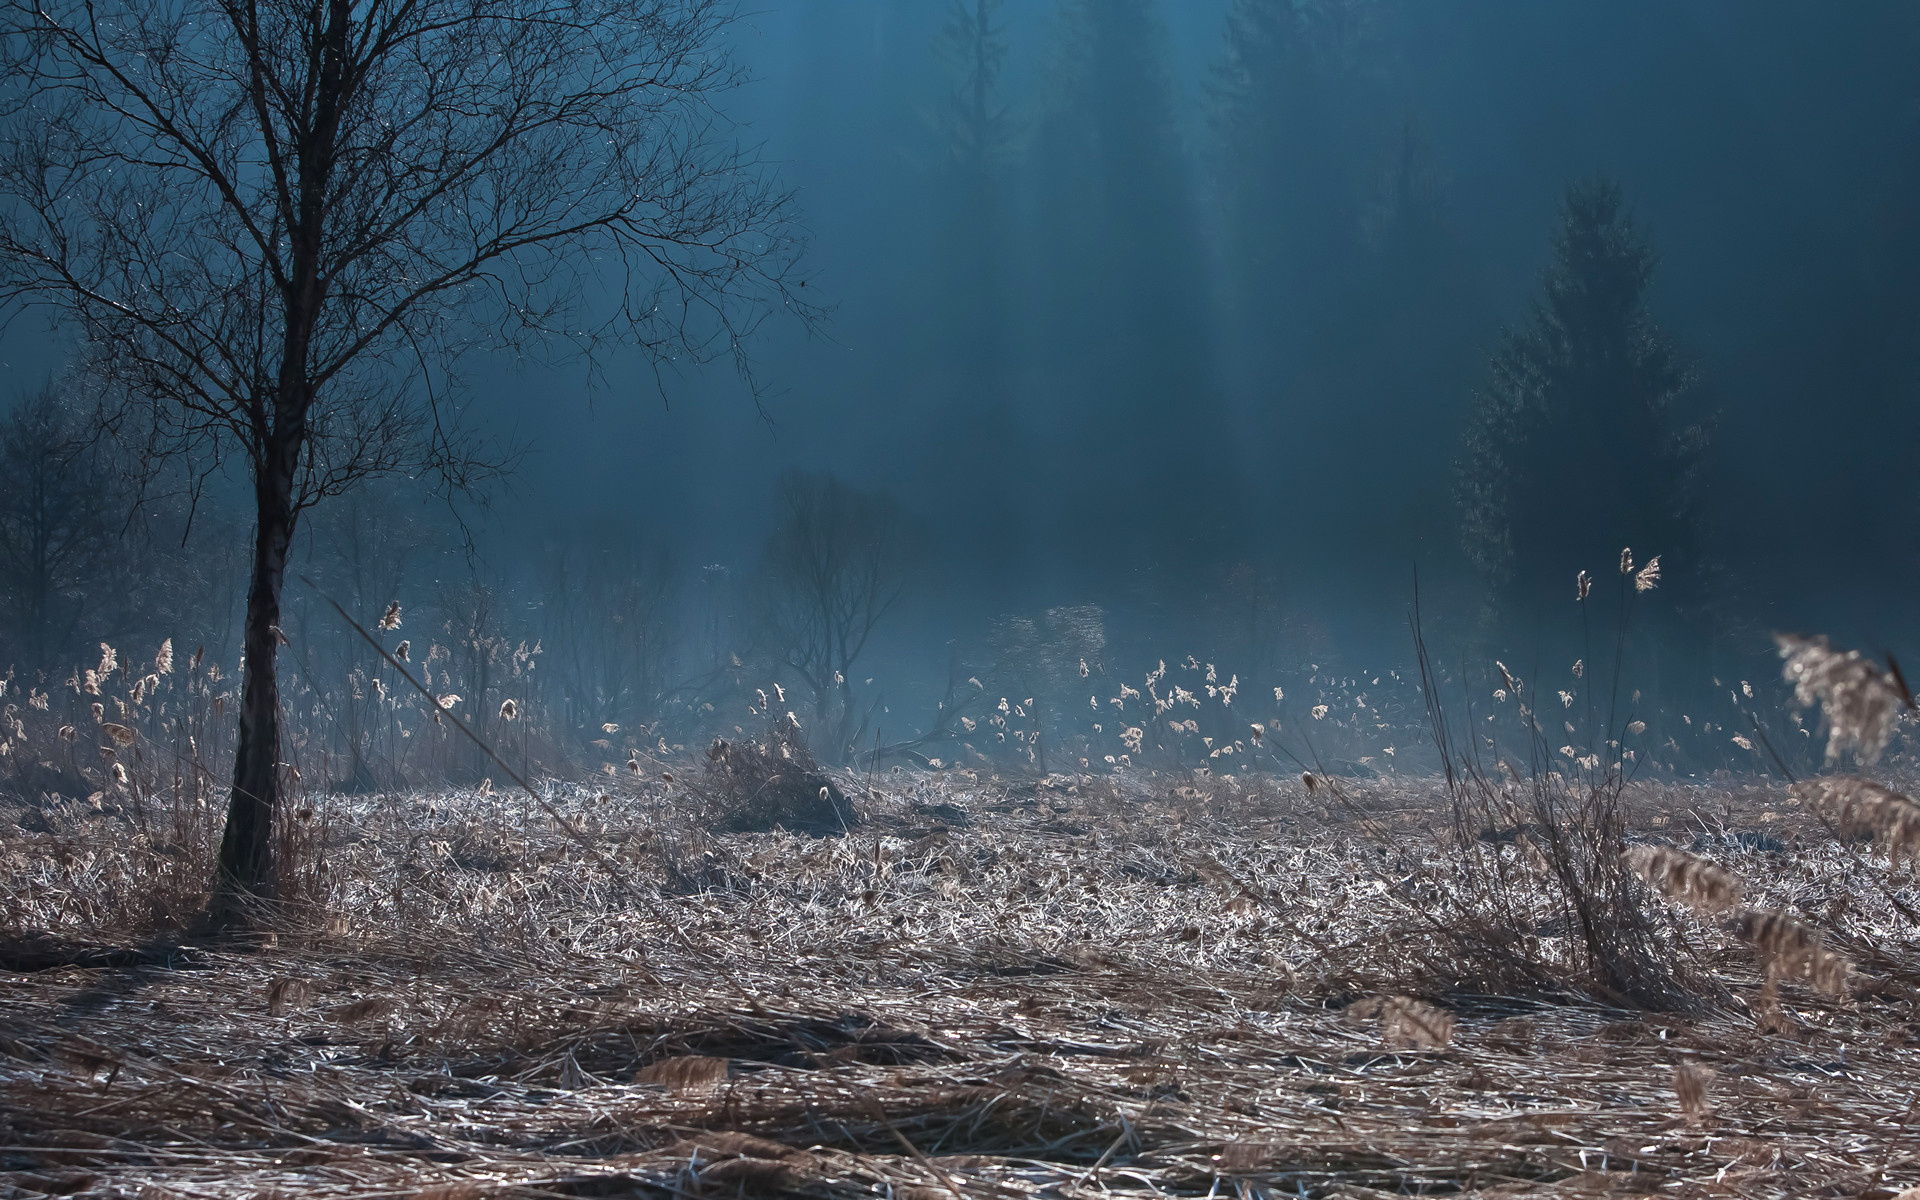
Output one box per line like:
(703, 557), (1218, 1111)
(211, 455), (294, 927)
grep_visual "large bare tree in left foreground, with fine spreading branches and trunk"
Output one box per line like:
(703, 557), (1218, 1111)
(0, 0), (810, 922)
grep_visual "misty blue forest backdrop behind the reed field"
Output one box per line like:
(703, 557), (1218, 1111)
(0, 0), (1920, 785)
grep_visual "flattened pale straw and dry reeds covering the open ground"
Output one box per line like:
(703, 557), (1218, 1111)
(0, 774), (1920, 1200)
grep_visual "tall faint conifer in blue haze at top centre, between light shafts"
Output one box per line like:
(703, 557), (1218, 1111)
(1033, 0), (1233, 557)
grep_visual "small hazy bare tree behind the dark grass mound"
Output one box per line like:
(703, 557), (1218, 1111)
(758, 470), (908, 762)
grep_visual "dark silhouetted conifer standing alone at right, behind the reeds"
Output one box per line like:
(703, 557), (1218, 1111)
(1457, 180), (1707, 616)
